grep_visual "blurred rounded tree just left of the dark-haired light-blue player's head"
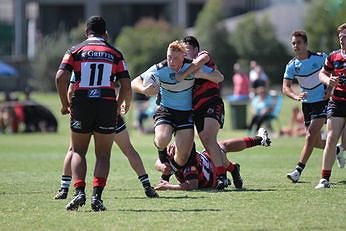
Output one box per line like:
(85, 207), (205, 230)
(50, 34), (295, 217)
(231, 13), (290, 83)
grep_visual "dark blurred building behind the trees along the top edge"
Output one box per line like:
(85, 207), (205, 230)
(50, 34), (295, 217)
(0, 0), (271, 58)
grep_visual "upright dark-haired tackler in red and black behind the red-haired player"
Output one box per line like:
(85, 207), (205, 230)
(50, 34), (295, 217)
(177, 36), (228, 190)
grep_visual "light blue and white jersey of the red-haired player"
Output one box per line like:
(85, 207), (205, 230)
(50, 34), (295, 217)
(141, 60), (213, 111)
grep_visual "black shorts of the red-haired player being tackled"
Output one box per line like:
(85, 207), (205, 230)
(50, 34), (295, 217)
(154, 106), (193, 131)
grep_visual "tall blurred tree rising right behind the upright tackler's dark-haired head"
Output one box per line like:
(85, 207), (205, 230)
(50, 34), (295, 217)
(195, 0), (238, 79)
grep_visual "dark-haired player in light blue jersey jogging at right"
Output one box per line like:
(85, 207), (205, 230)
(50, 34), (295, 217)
(282, 31), (345, 183)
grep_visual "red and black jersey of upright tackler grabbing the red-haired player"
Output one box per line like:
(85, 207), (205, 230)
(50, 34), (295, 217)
(192, 51), (221, 110)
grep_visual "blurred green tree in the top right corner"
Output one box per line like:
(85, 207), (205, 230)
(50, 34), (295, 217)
(304, 0), (346, 52)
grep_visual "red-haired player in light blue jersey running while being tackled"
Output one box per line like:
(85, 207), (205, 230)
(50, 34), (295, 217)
(132, 41), (223, 180)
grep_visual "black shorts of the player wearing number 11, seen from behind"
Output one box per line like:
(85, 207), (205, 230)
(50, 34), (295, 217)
(70, 97), (117, 134)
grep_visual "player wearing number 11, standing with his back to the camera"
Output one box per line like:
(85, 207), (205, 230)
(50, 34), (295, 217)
(55, 16), (132, 211)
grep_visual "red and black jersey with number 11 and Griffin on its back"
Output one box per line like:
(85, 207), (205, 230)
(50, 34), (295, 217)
(59, 37), (130, 98)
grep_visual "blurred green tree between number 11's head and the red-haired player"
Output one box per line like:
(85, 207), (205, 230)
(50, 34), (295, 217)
(115, 18), (183, 77)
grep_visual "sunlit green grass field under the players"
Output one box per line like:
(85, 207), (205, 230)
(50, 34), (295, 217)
(0, 94), (346, 230)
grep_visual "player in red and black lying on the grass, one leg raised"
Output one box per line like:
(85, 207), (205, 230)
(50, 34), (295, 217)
(155, 128), (271, 190)
